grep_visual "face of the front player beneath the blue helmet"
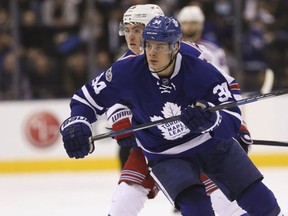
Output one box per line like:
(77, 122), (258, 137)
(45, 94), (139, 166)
(145, 41), (172, 75)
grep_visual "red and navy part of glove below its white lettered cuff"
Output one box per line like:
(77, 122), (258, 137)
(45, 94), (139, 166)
(112, 117), (137, 147)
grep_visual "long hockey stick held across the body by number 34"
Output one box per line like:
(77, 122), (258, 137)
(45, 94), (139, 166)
(90, 89), (288, 142)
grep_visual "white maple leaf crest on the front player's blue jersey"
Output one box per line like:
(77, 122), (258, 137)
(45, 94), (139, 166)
(150, 102), (190, 140)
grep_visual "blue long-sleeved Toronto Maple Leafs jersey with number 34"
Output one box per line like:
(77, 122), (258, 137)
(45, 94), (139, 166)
(70, 43), (241, 159)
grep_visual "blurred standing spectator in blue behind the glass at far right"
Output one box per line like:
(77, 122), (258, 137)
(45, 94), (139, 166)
(242, 2), (274, 92)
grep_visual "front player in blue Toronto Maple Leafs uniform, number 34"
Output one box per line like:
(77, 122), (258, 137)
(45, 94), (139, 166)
(61, 17), (280, 216)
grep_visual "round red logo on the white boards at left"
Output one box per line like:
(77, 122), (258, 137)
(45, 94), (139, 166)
(25, 112), (60, 147)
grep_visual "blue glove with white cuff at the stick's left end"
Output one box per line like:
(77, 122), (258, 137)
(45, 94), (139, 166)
(60, 116), (94, 159)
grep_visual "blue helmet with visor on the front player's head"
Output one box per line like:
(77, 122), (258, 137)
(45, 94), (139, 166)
(142, 16), (182, 46)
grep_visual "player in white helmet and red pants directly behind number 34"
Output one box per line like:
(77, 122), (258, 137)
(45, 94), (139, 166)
(106, 4), (250, 216)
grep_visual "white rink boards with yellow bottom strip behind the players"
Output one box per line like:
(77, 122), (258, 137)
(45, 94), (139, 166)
(0, 95), (288, 173)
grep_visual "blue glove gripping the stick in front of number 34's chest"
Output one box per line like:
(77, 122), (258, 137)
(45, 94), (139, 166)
(180, 101), (221, 133)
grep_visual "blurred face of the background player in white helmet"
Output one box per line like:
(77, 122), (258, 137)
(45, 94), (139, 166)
(181, 22), (203, 42)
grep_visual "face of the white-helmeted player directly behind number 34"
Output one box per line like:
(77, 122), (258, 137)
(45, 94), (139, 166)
(124, 24), (144, 54)
